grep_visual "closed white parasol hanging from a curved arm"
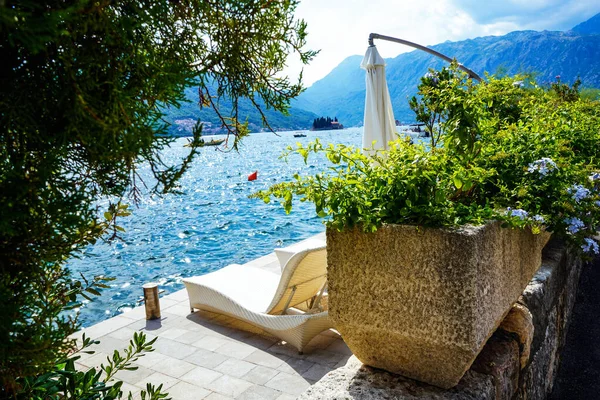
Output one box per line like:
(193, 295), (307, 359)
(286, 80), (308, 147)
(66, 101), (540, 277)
(360, 46), (398, 153)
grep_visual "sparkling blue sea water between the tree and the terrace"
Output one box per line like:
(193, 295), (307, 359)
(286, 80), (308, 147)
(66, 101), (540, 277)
(68, 128), (362, 326)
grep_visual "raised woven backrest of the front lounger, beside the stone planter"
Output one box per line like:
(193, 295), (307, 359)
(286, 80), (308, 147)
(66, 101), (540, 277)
(266, 246), (327, 314)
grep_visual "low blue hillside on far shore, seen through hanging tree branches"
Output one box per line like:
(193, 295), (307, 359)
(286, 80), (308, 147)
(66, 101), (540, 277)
(163, 87), (318, 136)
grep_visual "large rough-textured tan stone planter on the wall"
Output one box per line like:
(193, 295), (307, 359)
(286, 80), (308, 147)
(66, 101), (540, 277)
(327, 222), (550, 388)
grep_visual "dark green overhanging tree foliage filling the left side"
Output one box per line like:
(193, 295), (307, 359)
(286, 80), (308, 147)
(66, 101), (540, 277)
(0, 0), (315, 394)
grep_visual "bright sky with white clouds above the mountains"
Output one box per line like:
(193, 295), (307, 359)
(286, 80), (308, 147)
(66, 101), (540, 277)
(287, 0), (600, 86)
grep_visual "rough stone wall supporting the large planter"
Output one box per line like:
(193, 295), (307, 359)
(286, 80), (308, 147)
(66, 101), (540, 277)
(300, 240), (581, 400)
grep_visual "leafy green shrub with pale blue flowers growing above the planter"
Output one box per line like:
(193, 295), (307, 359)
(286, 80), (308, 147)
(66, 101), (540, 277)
(254, 65), (600, 253)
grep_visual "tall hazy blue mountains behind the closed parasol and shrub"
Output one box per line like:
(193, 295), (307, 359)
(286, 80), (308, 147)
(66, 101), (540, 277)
(292, 14), (600, 126)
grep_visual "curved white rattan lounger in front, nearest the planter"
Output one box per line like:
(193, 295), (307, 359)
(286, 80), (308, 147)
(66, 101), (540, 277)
(183, 246), (333, 352)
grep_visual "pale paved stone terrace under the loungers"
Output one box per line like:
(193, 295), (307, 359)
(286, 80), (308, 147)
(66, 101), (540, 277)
(74, 235), (352, 400)
